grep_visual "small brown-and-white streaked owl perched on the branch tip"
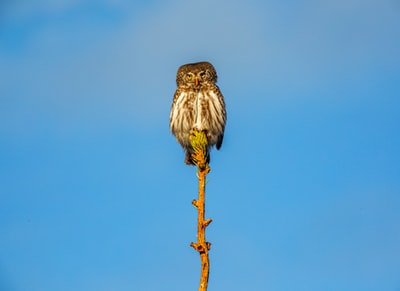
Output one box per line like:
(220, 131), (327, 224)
(169, 62), (226, 165)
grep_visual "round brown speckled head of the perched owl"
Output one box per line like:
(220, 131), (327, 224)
(176, 62), (217, 87)
